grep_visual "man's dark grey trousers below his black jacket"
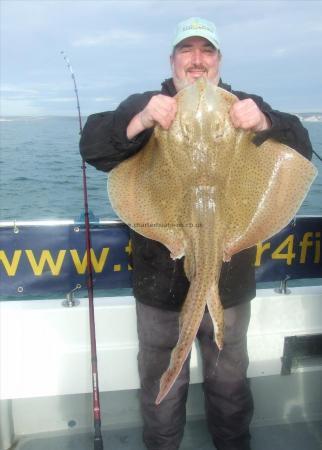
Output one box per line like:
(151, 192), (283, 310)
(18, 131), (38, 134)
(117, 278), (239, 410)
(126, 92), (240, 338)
(137, 302), (253, 450)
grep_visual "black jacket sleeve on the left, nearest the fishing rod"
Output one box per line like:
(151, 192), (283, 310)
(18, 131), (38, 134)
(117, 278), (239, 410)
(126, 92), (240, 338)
(79, 92), (155, 172)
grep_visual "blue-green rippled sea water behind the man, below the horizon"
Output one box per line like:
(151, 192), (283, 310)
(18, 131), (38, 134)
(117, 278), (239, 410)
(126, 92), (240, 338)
(0, 116), (322, 221)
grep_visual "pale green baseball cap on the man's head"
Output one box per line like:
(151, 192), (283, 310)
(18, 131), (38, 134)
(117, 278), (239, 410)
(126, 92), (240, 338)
(172, 17), (220, 50)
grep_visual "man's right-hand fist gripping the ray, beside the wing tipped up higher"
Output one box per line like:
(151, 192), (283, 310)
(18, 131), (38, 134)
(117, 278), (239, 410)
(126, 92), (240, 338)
(229, 98), (271, 132)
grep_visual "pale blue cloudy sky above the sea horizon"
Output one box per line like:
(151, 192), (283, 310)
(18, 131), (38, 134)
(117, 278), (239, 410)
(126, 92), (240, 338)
(0, 0), (322, 116)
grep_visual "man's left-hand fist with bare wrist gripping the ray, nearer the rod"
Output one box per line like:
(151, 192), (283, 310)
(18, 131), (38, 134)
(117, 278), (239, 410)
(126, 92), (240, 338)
(126, 94), (177, 139)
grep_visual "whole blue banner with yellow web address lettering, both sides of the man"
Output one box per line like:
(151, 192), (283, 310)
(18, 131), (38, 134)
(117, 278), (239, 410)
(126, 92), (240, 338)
(0, 217), (322, 298)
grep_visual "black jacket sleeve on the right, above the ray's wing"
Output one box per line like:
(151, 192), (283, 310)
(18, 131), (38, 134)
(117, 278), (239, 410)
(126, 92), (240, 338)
(234, 91), (312, 160)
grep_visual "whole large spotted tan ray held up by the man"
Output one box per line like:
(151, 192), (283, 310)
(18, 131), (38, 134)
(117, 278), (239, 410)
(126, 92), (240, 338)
(108, 78), (317, 404)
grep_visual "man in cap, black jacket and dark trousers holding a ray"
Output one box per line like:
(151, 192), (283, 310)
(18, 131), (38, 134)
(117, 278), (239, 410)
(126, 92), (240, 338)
(80, 18), (312, 450)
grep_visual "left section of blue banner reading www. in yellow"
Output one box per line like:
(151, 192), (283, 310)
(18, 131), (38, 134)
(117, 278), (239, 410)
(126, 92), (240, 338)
(0, 224), (132, 297)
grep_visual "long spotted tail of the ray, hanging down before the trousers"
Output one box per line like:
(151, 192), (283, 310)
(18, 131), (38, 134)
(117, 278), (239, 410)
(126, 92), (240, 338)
(156, 186), (224, 405)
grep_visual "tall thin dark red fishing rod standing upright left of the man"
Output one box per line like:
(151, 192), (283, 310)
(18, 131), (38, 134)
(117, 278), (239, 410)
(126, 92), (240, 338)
(61, 51), (104, 450)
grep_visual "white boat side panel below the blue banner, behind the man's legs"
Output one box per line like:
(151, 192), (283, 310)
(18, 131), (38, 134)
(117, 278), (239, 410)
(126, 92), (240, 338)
(0, 286), (322, 399)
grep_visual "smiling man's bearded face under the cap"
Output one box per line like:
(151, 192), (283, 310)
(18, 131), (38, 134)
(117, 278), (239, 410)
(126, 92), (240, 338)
(170, 37), (221, 91)
